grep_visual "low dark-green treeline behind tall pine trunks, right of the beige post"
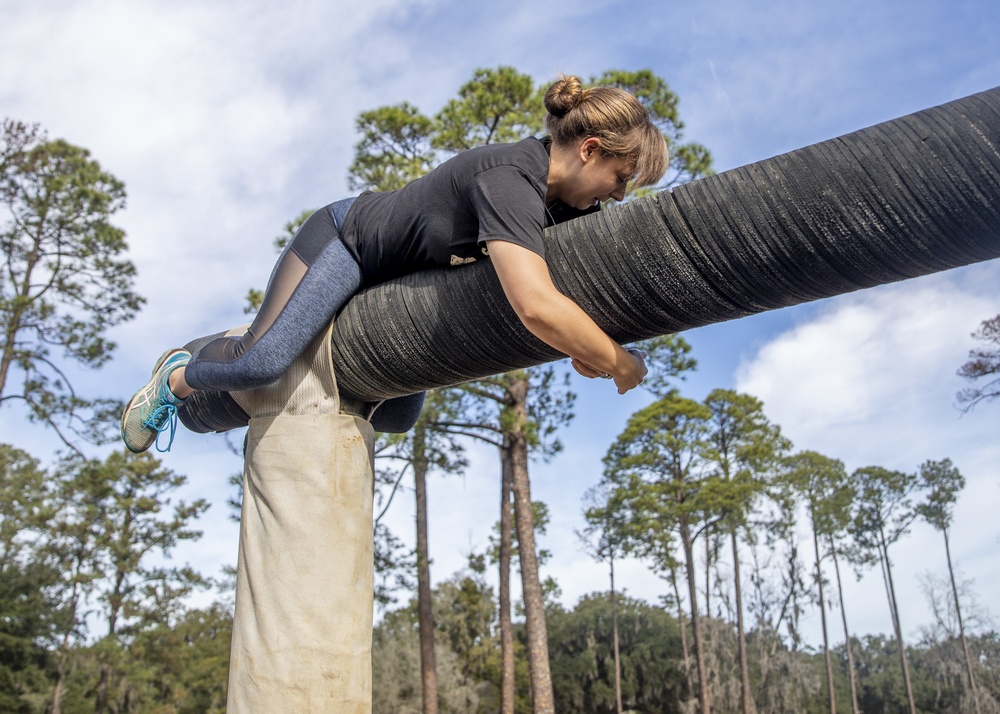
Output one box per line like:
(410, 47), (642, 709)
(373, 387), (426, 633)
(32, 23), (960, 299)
(373, 558), (1000, 714)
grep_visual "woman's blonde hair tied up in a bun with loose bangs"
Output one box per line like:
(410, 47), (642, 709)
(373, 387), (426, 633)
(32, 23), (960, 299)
(545, 75), (668, 187)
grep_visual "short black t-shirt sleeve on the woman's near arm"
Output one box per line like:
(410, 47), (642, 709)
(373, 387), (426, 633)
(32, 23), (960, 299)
(470, 166), (545, 258)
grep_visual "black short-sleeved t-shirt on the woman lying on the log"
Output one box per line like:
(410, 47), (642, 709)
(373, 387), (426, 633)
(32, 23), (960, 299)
(341, 138), (597, 285)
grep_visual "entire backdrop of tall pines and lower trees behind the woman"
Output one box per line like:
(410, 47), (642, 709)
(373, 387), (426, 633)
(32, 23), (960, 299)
(0, 67), (1000, 714)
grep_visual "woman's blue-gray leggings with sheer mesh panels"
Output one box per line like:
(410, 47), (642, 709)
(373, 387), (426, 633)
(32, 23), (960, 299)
(184, 198), (424, 432)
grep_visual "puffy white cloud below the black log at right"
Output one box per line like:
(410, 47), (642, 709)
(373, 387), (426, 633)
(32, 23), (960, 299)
(736, 265), (997, 465)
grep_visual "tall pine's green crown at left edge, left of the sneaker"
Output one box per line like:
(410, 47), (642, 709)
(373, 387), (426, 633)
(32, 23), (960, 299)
(0, 119), (143, 445)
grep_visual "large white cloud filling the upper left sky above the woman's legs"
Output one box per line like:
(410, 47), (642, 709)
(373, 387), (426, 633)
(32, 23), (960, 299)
(0, 0), (468, 358)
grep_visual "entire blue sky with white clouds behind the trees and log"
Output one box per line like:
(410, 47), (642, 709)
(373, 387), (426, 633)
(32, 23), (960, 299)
(0, 0), (1000, 641)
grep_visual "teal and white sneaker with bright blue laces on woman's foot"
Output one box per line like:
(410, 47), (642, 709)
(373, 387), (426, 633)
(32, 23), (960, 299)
(122, 349), (191, 454)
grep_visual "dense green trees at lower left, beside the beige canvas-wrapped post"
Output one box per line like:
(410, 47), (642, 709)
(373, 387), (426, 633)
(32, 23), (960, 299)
(0, 445), (225, 712)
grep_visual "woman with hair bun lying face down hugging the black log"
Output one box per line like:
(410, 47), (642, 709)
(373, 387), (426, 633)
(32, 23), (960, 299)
(122, 77), (667, 453)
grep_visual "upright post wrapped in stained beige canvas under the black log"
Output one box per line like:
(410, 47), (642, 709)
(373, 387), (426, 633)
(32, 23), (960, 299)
(227, 330), (374, 714)
